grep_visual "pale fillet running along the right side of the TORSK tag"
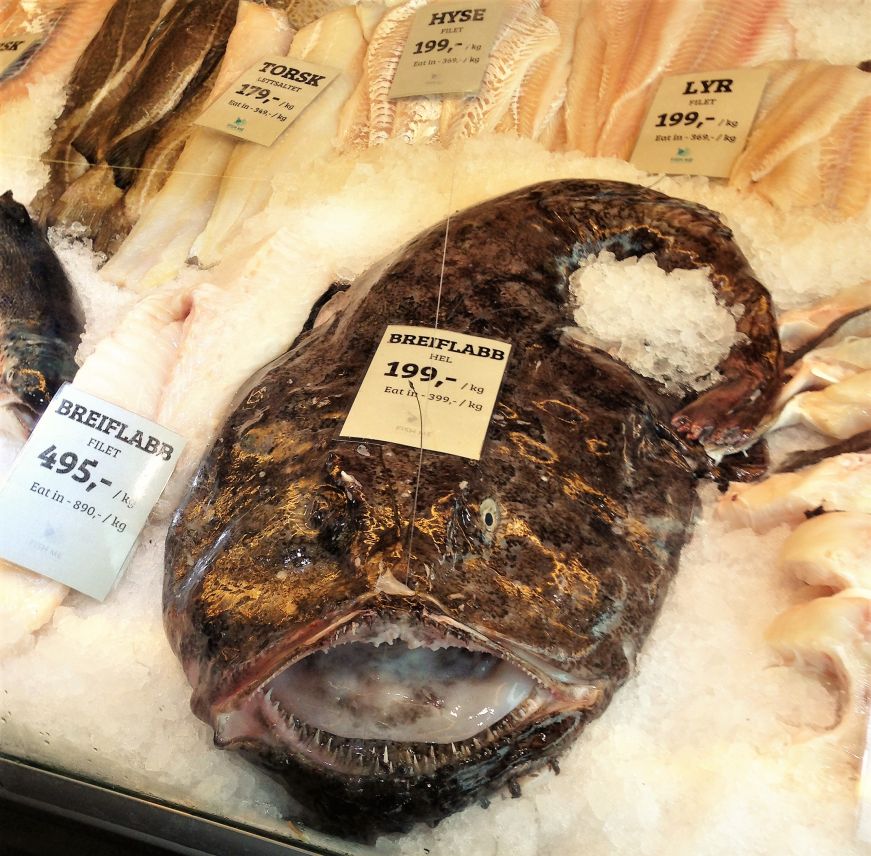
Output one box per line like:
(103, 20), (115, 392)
(190, 7), (366, 268)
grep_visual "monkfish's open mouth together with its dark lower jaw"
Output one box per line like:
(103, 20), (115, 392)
(211, 619), (611, 841)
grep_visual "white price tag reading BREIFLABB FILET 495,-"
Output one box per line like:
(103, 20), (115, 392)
(0, 384), (185, 600)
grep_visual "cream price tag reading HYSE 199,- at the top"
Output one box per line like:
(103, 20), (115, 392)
(388, 0), (505, 98)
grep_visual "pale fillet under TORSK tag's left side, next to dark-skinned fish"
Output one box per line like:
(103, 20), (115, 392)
(101, 0), (293, 291)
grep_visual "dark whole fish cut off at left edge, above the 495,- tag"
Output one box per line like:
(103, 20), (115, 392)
(0, 191), (83, 429)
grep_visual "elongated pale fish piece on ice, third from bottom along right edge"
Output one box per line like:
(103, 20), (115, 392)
(716, 453), (871, 532)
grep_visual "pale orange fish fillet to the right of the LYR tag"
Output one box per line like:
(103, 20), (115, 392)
(729, 65), (871, 220)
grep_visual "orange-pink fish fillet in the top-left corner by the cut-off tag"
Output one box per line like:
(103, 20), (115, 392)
(0, 0), (114, 102)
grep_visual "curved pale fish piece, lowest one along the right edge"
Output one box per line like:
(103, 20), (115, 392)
(766, 589), (871, 755)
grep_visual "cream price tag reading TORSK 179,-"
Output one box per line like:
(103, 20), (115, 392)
(194, 56), (342, 146)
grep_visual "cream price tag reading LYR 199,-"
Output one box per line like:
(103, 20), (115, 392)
(631, 68), (769, 178)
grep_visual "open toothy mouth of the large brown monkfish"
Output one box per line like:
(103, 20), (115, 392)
(213, 620), (602, 776)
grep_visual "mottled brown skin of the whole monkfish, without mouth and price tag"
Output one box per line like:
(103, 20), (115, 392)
(164, 181), (779, 838)
